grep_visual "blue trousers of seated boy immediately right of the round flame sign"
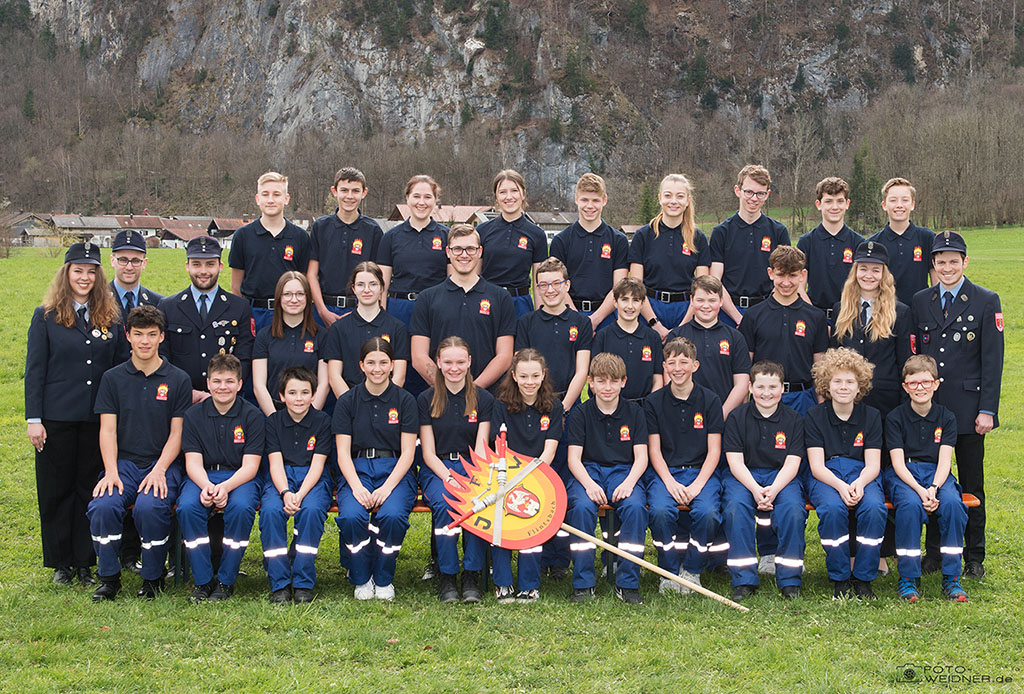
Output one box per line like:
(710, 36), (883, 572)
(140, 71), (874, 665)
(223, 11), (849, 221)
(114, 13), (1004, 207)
(565, 463), (647, 589)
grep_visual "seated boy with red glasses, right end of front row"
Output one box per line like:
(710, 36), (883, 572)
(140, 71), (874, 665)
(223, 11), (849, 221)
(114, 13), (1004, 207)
(882, 354), (967, 603)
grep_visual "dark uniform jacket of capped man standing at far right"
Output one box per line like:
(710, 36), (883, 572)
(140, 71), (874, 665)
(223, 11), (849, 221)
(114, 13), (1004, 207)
(911, 277), (1004, 434)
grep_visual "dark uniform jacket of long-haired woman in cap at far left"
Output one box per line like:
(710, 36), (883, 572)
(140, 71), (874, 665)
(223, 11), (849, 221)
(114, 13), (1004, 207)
(25, 306), (129, 422)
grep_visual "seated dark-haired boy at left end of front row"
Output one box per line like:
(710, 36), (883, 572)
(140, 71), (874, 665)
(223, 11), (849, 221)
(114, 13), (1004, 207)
(88, 306), (191, 602)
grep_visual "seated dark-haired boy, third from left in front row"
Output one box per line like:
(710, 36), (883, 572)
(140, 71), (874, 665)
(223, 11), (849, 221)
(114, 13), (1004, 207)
(259, 366), (334, 604)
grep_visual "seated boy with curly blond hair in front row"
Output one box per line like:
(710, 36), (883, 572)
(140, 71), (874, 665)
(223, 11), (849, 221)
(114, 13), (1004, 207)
(804, 347), (888, 600)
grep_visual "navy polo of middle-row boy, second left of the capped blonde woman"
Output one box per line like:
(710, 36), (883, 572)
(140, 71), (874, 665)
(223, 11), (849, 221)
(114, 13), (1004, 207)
(665, 318), (752, 402)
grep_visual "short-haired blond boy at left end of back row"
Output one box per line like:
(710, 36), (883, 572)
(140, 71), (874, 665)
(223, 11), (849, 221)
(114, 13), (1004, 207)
(227, 171), (309, 333)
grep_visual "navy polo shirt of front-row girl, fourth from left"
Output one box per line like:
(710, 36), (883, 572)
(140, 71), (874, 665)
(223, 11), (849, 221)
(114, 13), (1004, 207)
(331, 383), (420, 456)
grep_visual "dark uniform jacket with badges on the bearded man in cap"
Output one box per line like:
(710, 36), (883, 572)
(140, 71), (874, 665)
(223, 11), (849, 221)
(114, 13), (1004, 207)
(160, 287), (255, 390)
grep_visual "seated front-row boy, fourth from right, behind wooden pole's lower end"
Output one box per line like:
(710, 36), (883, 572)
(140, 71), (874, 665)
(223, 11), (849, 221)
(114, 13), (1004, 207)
(644, 338), (725, 593)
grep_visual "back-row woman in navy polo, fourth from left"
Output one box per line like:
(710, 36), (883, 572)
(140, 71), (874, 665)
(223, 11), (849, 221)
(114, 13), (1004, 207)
(476, 169), (548, 317)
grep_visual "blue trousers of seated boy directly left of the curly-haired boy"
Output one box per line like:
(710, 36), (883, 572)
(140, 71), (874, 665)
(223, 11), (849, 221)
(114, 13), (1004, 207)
(722, 468), (807, 588)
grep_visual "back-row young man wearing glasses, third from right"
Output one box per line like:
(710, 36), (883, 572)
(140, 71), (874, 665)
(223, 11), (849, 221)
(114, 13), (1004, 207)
(712, 164), (790, 326)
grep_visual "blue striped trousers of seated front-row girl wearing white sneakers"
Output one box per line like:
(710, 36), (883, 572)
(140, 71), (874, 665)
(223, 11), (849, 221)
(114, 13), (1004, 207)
(337, 458), (416, 585)
